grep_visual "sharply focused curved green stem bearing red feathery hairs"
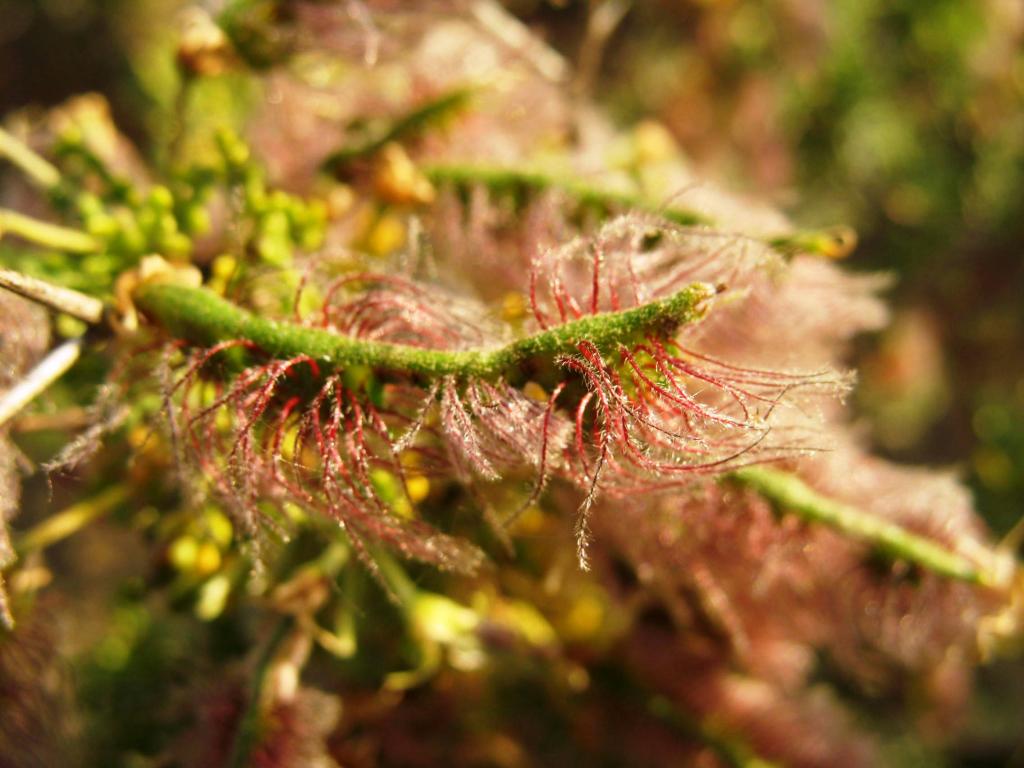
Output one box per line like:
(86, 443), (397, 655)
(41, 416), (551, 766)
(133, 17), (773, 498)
(135, 283), (715, 379)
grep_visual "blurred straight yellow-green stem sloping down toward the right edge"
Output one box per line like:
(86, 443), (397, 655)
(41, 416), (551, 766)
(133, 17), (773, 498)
(728, 466), (998, 586)
